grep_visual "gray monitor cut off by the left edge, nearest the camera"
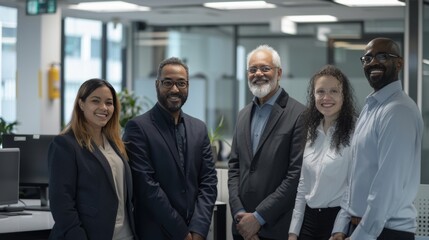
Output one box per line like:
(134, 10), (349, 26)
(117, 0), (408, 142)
(0, 148), (19, 205)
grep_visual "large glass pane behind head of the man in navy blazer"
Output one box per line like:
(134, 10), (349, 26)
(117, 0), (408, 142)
(132, 26), (237, 152)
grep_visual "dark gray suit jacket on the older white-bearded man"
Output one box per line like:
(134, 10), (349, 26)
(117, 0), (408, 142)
(228, 89), (305, 239)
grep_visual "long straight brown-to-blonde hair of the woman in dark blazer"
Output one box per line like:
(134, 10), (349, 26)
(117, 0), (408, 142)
(60, 78), (128, 159)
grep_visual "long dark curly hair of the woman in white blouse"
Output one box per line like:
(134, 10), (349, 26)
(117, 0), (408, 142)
(304, 65), (357, 151)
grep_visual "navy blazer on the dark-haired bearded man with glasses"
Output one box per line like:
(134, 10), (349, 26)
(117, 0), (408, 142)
(123, 103), (217, 240)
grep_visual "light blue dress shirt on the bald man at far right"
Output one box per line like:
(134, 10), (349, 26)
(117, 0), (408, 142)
(333, 81), (423, 240)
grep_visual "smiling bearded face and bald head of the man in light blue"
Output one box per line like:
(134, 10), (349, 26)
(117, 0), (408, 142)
(363, 38), (403, 91)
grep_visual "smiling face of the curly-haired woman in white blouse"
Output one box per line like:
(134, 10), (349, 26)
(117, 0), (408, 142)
(314, 76), (343, 122)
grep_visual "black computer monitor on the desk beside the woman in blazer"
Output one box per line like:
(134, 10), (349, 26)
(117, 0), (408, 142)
(3, 134), (55, 211)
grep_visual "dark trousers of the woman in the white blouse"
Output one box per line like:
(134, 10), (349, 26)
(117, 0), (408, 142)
(298, 206), (341, 240)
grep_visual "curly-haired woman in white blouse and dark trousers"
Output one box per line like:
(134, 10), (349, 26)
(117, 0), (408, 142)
(288, 65), (357, 240)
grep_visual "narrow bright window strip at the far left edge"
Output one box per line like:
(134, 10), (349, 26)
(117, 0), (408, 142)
(0, 6), (17, 122)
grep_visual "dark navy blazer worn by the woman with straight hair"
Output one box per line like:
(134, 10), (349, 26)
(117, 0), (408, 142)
(48, 132), (135, 240)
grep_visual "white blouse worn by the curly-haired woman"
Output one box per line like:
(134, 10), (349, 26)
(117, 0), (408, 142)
(289, 122), (350, 235)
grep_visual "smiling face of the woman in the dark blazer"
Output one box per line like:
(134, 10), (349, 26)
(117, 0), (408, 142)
(79, 86), (115, 131)
